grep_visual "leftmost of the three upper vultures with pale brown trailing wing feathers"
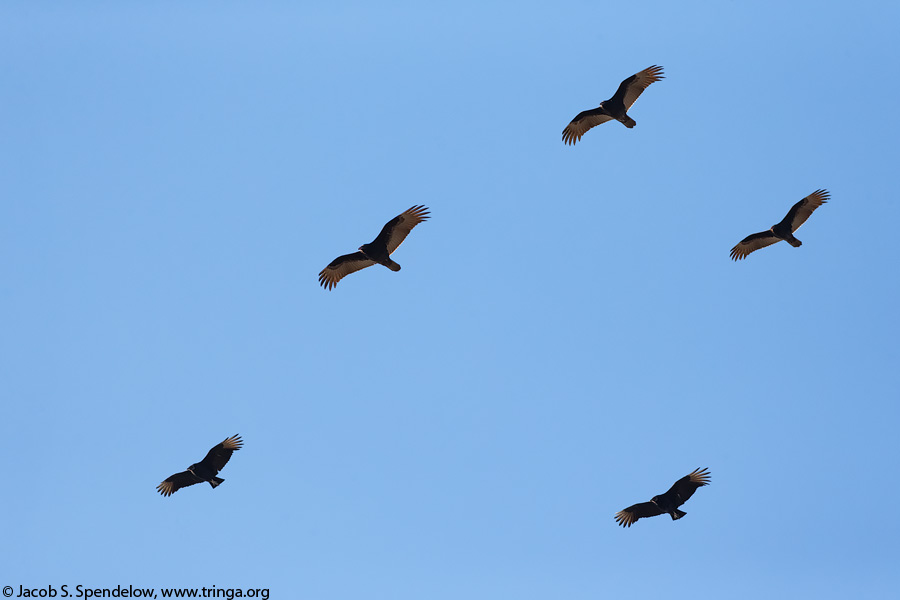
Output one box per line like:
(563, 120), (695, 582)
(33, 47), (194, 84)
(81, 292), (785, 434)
(319, 206), (428, 290)
